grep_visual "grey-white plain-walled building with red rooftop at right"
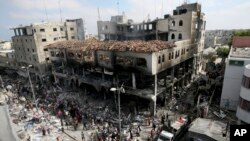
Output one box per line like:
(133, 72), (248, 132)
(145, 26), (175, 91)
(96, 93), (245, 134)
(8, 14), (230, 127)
(220, 37), (250, 111)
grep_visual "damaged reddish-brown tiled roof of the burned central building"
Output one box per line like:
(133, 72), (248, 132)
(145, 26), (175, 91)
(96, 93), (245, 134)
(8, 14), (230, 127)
(45, 38), (176, 52)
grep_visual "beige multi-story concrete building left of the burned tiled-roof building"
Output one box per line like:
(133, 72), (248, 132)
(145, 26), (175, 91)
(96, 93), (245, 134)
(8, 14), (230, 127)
(12, 19), (84, 74)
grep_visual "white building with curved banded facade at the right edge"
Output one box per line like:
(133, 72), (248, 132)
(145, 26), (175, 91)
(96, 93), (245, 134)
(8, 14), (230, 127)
(236, 64), (250, 124)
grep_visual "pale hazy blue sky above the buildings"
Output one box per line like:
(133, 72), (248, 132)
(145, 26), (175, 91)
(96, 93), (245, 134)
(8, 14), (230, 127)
(0, 0), (250, 40)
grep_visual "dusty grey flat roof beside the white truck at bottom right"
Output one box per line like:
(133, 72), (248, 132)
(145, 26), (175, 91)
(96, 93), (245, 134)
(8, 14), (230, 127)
(188, 118), (228, 141)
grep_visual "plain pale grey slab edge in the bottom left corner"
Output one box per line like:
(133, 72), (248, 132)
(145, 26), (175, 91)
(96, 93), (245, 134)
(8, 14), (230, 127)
(0, 105), (16, 141)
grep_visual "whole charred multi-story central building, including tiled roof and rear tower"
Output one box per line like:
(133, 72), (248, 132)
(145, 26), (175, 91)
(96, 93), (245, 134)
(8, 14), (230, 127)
(47, 3), (205, 114)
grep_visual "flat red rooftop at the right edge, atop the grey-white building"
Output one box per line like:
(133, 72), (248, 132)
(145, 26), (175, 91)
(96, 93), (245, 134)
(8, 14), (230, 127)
(232, 36), (250, 48)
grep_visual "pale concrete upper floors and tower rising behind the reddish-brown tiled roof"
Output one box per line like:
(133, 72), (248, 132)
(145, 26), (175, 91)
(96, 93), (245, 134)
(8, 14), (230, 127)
(97, 3), (206, 73)
